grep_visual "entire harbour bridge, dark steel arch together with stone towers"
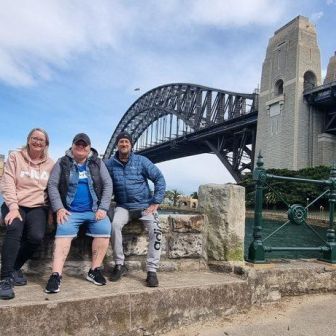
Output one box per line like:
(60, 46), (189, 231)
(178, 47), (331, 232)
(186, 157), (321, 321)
(104, 16), (336, 182)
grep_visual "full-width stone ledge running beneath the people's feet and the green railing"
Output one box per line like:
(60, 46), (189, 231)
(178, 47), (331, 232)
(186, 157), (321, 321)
(0, 261), (336, 336)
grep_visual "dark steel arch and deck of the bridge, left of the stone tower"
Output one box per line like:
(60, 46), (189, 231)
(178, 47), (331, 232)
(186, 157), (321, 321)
(104, 83), (258, 181)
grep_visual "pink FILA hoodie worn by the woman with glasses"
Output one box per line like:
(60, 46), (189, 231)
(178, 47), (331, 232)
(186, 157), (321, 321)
(1, 149), (54, 210)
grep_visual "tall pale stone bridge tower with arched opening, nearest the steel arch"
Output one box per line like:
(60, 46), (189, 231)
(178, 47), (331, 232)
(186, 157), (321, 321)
(256, 16), (323, 170)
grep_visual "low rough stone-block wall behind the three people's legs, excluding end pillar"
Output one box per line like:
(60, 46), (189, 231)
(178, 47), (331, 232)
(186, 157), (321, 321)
(0, 214), (207, 274)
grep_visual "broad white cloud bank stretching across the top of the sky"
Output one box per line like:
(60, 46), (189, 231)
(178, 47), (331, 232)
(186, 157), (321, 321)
(0, 0), (287, 86)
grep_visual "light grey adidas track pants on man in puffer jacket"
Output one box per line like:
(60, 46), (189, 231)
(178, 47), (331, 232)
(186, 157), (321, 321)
(111, 207), (162, 272)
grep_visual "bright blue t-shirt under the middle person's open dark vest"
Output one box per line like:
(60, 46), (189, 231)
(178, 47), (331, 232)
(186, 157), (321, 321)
(70, 164), (92, 212)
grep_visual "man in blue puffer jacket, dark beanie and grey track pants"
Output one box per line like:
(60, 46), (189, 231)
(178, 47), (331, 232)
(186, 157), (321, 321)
(105, 132), (166, 287)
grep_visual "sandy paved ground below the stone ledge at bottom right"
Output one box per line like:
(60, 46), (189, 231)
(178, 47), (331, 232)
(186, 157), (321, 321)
(162, 294), (336, 336)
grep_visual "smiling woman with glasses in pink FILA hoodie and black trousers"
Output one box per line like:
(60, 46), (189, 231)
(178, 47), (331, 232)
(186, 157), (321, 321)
(0, 128), (54, 299)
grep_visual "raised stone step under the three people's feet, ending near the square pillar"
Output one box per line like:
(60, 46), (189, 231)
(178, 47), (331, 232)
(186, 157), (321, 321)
(0, 271), (250, 336)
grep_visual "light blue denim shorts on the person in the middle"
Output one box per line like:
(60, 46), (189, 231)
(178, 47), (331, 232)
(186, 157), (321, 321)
(56, 211), (112, 238)
